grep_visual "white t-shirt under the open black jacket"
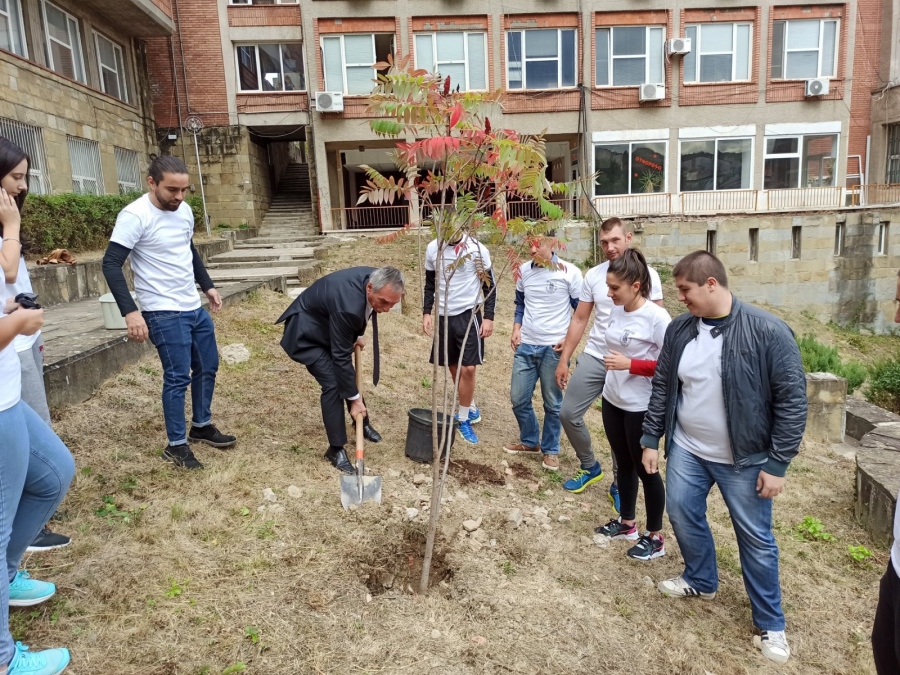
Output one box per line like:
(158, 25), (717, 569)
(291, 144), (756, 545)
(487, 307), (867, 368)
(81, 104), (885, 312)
(672, 320), (734, 464)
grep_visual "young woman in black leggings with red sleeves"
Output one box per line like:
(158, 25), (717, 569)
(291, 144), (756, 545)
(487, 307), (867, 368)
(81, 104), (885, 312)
(595, 249), (671, 560)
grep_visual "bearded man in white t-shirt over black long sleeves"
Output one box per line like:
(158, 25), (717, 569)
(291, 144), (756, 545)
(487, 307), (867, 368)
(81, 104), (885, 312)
(103, 157), (237, 469)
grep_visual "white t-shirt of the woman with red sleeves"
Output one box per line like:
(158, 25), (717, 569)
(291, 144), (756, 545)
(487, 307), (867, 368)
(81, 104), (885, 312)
(603, 300), (672, 412)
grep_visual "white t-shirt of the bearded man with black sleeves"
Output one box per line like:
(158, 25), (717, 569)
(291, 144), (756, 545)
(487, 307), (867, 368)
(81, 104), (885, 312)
(110, 194), (200, 312)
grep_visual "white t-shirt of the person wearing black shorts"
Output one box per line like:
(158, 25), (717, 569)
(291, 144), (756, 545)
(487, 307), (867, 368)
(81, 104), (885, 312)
(425, 236), (496, 316)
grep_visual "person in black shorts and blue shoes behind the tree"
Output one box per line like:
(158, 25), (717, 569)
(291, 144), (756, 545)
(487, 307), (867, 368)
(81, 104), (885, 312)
(422, 234), (497, 444)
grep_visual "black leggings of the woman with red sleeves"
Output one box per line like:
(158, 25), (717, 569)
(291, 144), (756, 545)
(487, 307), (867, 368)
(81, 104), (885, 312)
(603, 398), (666, 532)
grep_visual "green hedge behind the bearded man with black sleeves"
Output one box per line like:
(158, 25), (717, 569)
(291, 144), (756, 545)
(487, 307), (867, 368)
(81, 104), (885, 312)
(22, 192), (203, 255)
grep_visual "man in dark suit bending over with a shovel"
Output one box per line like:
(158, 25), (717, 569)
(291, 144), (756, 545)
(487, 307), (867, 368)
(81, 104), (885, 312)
(276, 267), (404, 474)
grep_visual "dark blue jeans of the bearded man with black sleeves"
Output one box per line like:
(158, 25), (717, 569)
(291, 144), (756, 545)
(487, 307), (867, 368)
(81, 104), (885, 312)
(143, 307), (219, 445)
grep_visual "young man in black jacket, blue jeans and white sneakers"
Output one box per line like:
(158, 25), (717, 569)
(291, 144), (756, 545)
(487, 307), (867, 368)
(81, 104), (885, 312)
(641, 251), (807, 663)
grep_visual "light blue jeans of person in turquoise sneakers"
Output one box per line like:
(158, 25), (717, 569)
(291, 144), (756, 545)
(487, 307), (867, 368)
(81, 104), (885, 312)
(0, 401), (75, 666)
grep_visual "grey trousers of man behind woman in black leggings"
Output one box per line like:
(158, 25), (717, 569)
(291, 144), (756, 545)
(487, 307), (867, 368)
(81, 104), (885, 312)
(559, 352), (616, 475)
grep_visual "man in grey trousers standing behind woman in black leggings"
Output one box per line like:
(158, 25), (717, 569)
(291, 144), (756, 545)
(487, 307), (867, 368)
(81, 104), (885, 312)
(556, 218), (663, 500)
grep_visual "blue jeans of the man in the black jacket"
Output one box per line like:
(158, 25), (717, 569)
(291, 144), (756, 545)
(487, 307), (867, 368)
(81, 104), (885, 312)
(666, 440), (784, 631)
